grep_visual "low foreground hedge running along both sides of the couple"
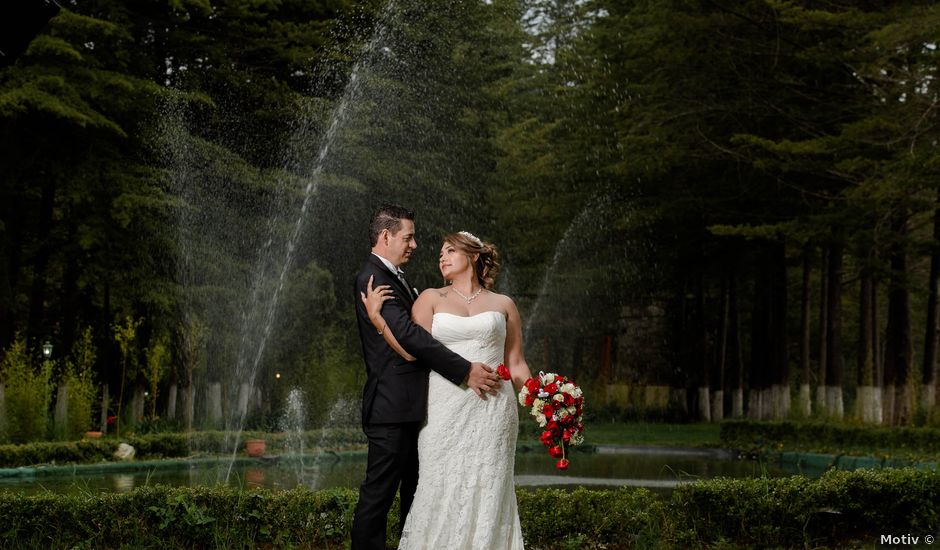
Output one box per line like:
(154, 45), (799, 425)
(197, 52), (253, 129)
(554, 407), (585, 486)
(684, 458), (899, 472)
(0, 469), (940, 550)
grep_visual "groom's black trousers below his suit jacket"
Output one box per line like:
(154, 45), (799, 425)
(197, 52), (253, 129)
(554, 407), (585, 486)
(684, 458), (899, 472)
(352, 422), (421, 550)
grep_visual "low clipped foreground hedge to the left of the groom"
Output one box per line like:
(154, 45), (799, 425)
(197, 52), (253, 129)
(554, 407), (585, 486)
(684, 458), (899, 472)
(0, 487), (356, 549)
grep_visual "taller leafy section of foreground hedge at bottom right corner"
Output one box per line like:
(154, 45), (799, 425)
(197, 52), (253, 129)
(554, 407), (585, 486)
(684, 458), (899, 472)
(666, 469), (940, 548)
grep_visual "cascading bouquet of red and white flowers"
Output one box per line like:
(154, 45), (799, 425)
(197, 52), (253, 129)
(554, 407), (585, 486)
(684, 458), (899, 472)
(519, 372), (584, 470)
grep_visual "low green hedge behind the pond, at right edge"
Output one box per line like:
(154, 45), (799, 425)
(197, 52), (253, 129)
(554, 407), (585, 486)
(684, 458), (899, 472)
(720, 420), (940, 458)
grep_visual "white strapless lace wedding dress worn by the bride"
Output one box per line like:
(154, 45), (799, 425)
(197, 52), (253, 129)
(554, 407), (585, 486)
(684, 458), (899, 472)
(398, 311), (522, 550)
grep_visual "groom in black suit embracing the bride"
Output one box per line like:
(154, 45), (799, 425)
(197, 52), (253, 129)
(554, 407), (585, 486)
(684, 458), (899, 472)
(352, 204), (499, 550)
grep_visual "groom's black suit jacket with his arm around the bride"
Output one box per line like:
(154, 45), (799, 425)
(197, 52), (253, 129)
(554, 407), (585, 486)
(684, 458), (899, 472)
(353, 254), (470, 424)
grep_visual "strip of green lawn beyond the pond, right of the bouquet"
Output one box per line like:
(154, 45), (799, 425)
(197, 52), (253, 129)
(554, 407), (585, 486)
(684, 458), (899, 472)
(584, 422), (721, 447)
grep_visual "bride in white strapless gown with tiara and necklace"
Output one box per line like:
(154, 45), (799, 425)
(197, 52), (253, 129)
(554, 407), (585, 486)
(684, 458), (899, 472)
(363, 231), (531, 549)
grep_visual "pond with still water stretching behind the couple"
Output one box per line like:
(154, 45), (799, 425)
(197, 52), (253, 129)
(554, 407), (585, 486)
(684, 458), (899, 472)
(0, 446), (822, 493)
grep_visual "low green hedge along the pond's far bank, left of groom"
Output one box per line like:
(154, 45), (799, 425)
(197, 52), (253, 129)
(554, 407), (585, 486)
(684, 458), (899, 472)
(0, 429), (366, 468)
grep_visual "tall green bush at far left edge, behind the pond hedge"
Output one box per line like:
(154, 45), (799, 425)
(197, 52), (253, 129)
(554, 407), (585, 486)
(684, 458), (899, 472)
(0, 339), (52, 443)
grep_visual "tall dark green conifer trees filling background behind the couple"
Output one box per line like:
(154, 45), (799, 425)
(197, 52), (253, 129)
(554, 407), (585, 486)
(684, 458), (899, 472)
(0, 0), (940, 429)
